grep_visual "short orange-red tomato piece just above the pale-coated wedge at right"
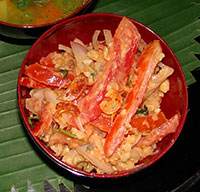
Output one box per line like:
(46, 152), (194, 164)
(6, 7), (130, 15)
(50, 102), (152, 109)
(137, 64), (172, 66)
(130, 112), (167, 132)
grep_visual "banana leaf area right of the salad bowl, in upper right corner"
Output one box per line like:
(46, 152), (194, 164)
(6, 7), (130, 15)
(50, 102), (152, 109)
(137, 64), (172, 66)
(94, 0), (200, 85)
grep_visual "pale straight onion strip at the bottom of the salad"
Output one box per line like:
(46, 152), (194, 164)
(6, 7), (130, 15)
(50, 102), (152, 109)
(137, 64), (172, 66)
(76, 146), (113, 174)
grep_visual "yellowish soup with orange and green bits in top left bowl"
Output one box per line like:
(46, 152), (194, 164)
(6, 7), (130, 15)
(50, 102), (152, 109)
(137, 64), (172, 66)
(0, 0), (87, 25)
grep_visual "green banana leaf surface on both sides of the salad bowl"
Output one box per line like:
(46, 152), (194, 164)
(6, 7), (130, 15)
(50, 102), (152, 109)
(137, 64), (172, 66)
(0, 0), (200, 192)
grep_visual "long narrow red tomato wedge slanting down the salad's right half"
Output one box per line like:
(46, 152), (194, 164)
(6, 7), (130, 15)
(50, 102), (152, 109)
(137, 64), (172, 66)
(104, 40), (163, 156)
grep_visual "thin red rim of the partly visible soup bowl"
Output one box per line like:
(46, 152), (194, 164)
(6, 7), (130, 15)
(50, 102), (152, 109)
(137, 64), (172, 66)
(0, 0), (92, 29)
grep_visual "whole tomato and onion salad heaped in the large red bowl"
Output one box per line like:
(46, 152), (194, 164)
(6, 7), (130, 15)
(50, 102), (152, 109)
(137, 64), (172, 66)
(20, 17), (180, 174)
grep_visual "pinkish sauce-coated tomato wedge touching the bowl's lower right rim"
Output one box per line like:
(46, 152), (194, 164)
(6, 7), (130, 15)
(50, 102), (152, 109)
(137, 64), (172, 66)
(137, 114), (180, 146)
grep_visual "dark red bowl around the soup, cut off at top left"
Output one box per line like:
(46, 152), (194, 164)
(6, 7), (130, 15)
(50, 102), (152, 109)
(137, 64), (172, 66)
(0, 0), (94, 39)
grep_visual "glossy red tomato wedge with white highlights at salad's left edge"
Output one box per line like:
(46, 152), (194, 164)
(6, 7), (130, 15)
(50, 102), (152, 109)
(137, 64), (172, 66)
(24, 63), (74, 88)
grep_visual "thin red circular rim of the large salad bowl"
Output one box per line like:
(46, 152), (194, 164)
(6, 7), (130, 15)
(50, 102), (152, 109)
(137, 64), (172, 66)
(17, 13), (188, 179)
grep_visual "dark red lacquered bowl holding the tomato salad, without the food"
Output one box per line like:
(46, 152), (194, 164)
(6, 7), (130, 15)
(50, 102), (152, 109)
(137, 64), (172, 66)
(17, 13), (188, 178)
